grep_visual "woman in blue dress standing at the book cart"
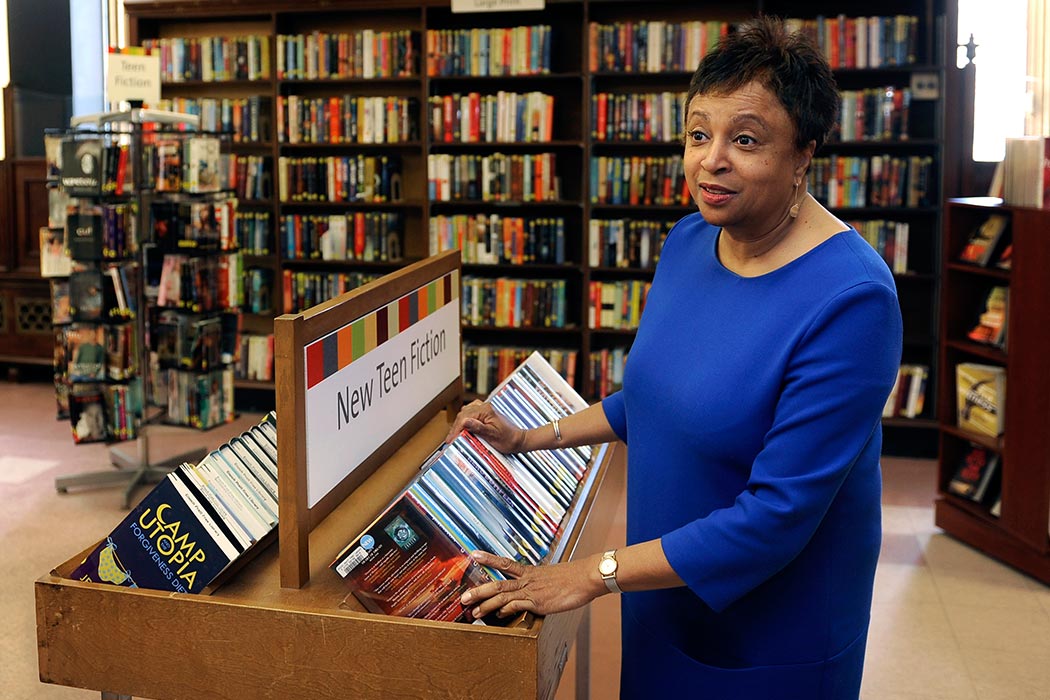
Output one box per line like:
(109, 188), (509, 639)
(449, 18), (901, 700)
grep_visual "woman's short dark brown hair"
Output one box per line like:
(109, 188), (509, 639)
(686, 16), (839, 149)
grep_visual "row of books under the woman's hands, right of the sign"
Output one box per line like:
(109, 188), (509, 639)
(331, 353), (591, 622)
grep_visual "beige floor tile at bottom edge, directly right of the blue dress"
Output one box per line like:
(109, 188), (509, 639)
(862, 635), (978, 700)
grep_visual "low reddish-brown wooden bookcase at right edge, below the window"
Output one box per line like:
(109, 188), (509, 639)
(936, 197), (1050, 582)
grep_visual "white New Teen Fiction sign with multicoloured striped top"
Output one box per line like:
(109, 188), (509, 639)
(305, 271), (460, 508)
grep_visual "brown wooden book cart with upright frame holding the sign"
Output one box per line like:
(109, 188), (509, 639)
(36, 253), (625, 700)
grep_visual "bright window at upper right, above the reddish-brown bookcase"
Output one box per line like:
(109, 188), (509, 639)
(959, 0), (1029, 161)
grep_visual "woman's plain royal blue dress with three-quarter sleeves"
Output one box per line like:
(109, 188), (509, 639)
(603, 213), (901, 700)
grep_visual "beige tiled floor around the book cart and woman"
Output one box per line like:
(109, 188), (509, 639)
(0, 381), (1050, 700)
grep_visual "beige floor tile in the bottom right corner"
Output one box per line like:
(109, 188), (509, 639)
(963, 646), (1050, 700)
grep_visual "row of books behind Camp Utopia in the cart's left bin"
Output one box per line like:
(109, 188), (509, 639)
(70, 411), (277, 593)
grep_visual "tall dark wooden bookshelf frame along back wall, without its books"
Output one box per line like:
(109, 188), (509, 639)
(125, 0), (953, 454)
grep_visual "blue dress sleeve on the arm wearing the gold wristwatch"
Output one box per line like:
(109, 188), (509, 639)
(663, 282), (901, 611)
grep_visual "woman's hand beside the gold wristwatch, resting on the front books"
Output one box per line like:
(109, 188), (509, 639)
(460, 552), (608, 618)
